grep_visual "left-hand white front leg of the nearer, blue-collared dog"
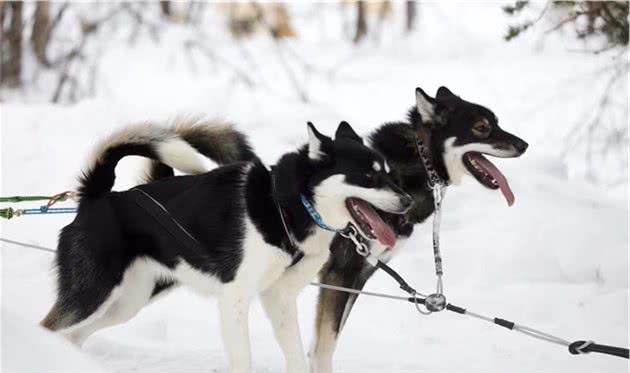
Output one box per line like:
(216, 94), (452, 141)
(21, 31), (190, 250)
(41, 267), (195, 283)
(219, 293), (251, 373)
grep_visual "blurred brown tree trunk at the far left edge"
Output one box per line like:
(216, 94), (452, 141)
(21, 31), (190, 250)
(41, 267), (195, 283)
(0, 1), (24, 87)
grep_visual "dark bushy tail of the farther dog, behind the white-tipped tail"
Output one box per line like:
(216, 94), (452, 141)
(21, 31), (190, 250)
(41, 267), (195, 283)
(145, 117), (258, 182)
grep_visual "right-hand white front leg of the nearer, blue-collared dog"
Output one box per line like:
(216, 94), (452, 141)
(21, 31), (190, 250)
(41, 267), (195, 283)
(260, 280), (307, 373)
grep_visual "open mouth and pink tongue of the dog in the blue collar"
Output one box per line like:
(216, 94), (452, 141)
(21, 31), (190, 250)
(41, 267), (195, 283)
(346, 197), (396, 248)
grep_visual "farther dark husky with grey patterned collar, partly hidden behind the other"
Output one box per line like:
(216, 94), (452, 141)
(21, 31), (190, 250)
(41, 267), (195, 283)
(141, 87), (528, 372)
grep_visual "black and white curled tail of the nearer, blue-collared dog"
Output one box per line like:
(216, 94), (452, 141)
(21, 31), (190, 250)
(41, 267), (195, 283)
(79, 123), (207, 199)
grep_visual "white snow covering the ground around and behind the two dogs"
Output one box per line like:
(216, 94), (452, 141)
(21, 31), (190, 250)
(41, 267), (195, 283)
(0, 3), (629, 372)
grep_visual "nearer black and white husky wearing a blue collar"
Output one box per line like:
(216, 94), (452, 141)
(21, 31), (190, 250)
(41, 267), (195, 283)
(42, 122), (413, 372)
